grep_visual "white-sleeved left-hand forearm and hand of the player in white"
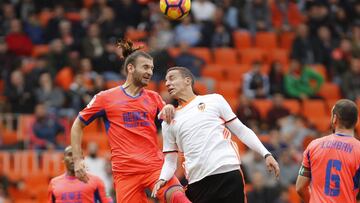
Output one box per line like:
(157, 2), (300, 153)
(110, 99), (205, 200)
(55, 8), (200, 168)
(151, 152), (178, 198)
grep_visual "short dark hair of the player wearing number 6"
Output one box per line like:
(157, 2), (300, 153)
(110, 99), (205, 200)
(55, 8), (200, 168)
(332, 99), (358, 129)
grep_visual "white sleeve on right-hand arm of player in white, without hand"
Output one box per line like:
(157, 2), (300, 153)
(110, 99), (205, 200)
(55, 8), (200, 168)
(225, 118), (270, 157)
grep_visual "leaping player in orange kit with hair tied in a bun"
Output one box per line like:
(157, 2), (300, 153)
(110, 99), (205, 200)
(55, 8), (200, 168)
(71, 41), (189, 203)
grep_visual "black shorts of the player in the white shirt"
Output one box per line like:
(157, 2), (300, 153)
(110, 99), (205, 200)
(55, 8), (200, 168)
(186, 170), (246, 203)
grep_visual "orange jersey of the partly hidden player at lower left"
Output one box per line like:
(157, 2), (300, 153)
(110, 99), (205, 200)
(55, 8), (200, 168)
(48, 174), (112, 203)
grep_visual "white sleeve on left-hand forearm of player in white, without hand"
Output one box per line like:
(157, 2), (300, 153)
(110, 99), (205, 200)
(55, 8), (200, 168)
(159, 152), (178, 181)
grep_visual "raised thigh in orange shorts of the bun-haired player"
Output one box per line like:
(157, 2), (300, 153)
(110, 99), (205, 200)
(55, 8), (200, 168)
(148, 170), (183, 202)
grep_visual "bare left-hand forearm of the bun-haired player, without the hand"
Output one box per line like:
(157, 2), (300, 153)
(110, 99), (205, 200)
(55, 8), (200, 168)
(70, 117), (86, 159)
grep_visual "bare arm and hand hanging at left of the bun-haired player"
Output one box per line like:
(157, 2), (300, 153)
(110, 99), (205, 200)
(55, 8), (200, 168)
(71, 118), (89, 183)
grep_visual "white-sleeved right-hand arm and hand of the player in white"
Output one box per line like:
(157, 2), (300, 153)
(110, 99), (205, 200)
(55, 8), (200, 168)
(226, 118), (280, 178)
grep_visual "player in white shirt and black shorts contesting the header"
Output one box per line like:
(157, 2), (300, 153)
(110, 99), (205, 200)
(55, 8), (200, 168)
(152, 67), (280, 203)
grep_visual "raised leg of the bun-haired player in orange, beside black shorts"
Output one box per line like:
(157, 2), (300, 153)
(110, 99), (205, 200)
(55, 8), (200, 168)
(148, 170), (190, 203)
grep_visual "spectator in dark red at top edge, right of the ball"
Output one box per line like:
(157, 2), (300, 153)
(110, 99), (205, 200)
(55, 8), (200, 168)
(270, 0), (303, 32)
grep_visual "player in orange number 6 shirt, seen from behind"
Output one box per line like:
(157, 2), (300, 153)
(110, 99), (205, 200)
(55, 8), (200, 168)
(296, 99), (360, 203)
